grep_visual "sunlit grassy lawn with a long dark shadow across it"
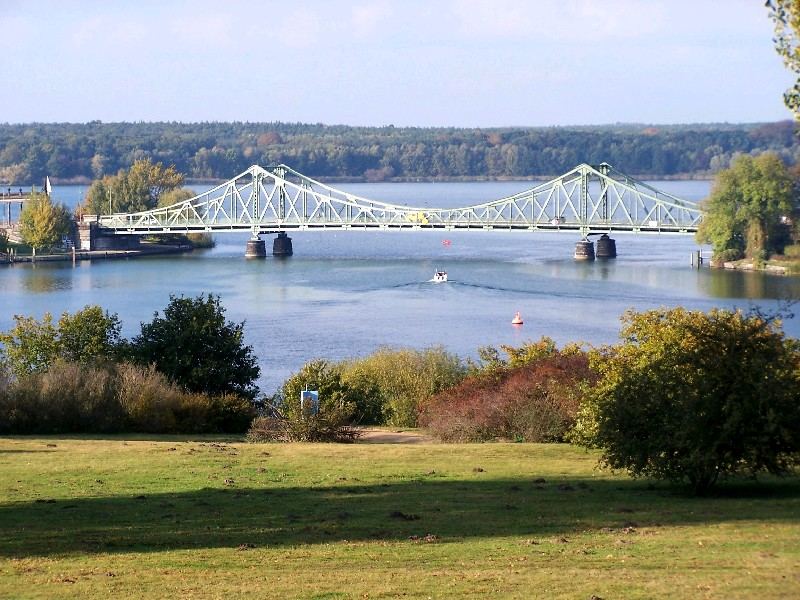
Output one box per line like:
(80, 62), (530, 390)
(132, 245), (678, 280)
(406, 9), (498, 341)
(0, 438), (800, 600)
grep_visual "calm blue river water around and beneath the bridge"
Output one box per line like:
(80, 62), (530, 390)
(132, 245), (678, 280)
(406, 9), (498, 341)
(0, 181), (800, 393)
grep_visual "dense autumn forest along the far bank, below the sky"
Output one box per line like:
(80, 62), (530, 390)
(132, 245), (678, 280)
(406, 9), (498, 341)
(0, 121), (800, 185)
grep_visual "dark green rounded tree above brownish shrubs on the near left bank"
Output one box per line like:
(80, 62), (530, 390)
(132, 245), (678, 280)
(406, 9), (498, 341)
(130, 294), (260, 399)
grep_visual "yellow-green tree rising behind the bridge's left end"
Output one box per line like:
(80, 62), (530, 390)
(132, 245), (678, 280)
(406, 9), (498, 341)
(82, 158), (183, 214)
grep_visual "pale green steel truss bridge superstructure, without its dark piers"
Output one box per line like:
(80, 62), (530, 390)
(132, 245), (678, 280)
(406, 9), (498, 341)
(97, 163), (702, 237)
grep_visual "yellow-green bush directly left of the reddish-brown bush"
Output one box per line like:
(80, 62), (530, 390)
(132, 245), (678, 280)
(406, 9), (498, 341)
(341, 347), (466, 427)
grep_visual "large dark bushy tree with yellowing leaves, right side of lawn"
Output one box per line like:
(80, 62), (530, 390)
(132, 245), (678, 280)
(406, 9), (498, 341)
(575, 308), (800, 493)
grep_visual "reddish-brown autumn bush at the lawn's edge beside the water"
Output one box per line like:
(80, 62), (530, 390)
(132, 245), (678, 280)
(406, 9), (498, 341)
(420, 346), (595, 442)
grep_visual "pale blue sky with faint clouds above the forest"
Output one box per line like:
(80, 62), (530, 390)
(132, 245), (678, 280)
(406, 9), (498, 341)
(0, 0), (792, 127)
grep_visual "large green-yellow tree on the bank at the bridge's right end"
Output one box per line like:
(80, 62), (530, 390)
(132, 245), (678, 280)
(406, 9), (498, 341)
(697, 152), (798, 260)
